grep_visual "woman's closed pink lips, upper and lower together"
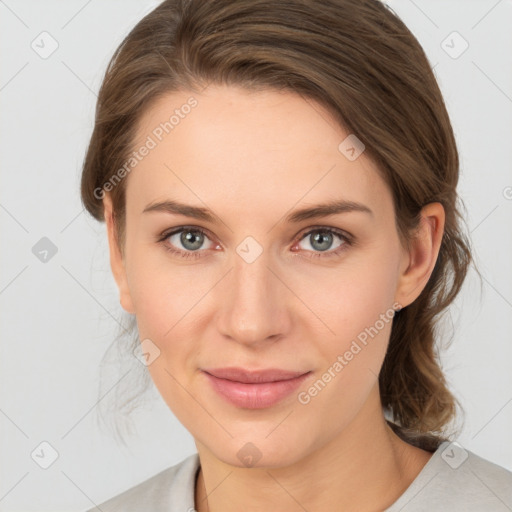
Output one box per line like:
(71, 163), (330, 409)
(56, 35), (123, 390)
(202, 368), (311, 409)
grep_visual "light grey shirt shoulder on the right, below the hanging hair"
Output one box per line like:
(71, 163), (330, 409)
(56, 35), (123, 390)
(387, 442), (512, 512)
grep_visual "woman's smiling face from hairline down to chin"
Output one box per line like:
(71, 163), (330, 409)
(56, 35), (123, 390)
(106, 86), (440, 466)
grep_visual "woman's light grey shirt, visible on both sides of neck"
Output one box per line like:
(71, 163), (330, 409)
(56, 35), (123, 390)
(87, 442), (512, 512)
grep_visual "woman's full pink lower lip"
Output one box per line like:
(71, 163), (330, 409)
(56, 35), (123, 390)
(203, 372), (311, 409)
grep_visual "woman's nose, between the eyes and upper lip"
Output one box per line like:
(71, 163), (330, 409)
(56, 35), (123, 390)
(218, 252), (293, 348)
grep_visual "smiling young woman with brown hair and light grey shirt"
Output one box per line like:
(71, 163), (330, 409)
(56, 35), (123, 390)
(82, 0), (512, 512)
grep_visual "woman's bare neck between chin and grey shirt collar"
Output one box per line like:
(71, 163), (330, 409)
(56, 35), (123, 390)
(195, 387), (432, 512)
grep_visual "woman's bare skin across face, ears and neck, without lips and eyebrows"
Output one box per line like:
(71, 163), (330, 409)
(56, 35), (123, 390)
(104, 86), (444, 512)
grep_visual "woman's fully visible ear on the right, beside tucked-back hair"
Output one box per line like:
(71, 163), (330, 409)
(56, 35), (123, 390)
(395, 202), (445, 308)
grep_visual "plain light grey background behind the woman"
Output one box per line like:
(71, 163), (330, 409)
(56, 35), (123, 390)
(0, 0), (512, 511)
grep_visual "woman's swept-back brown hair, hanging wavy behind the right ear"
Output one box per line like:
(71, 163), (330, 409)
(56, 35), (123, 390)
(81, 0), (480, 446)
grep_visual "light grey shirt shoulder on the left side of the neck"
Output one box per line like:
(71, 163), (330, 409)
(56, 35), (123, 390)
(83, 453), (199, 512)
